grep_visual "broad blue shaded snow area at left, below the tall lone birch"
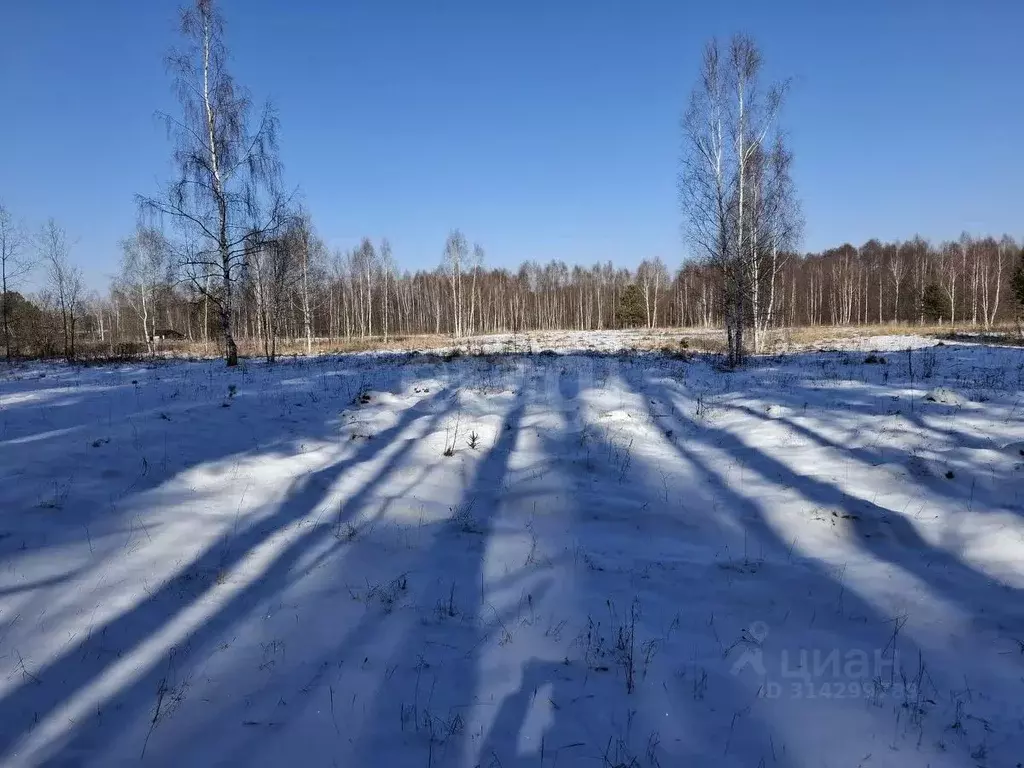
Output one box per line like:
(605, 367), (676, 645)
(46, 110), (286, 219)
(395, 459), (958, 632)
(0, 359), (428, 563)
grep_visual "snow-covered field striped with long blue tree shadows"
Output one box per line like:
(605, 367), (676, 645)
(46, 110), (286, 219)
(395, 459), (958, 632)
(0, 338), (1024, 768)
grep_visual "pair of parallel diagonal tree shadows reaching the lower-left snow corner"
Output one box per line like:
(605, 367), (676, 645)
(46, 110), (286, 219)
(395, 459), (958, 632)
(0, 380), (456, 764)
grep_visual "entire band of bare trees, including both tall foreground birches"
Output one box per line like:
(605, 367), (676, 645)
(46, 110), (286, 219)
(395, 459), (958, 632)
(0, 0), (1024, 365)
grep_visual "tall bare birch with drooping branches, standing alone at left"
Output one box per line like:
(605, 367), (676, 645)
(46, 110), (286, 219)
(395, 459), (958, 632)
(140, 0), (287, 366)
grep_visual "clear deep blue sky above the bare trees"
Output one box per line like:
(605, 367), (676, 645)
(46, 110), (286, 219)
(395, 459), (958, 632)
(0, 0), (1024, 288)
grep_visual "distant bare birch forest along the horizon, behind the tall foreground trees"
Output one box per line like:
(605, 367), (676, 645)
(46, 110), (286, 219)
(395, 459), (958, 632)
(6, 220), (1020, 364)
